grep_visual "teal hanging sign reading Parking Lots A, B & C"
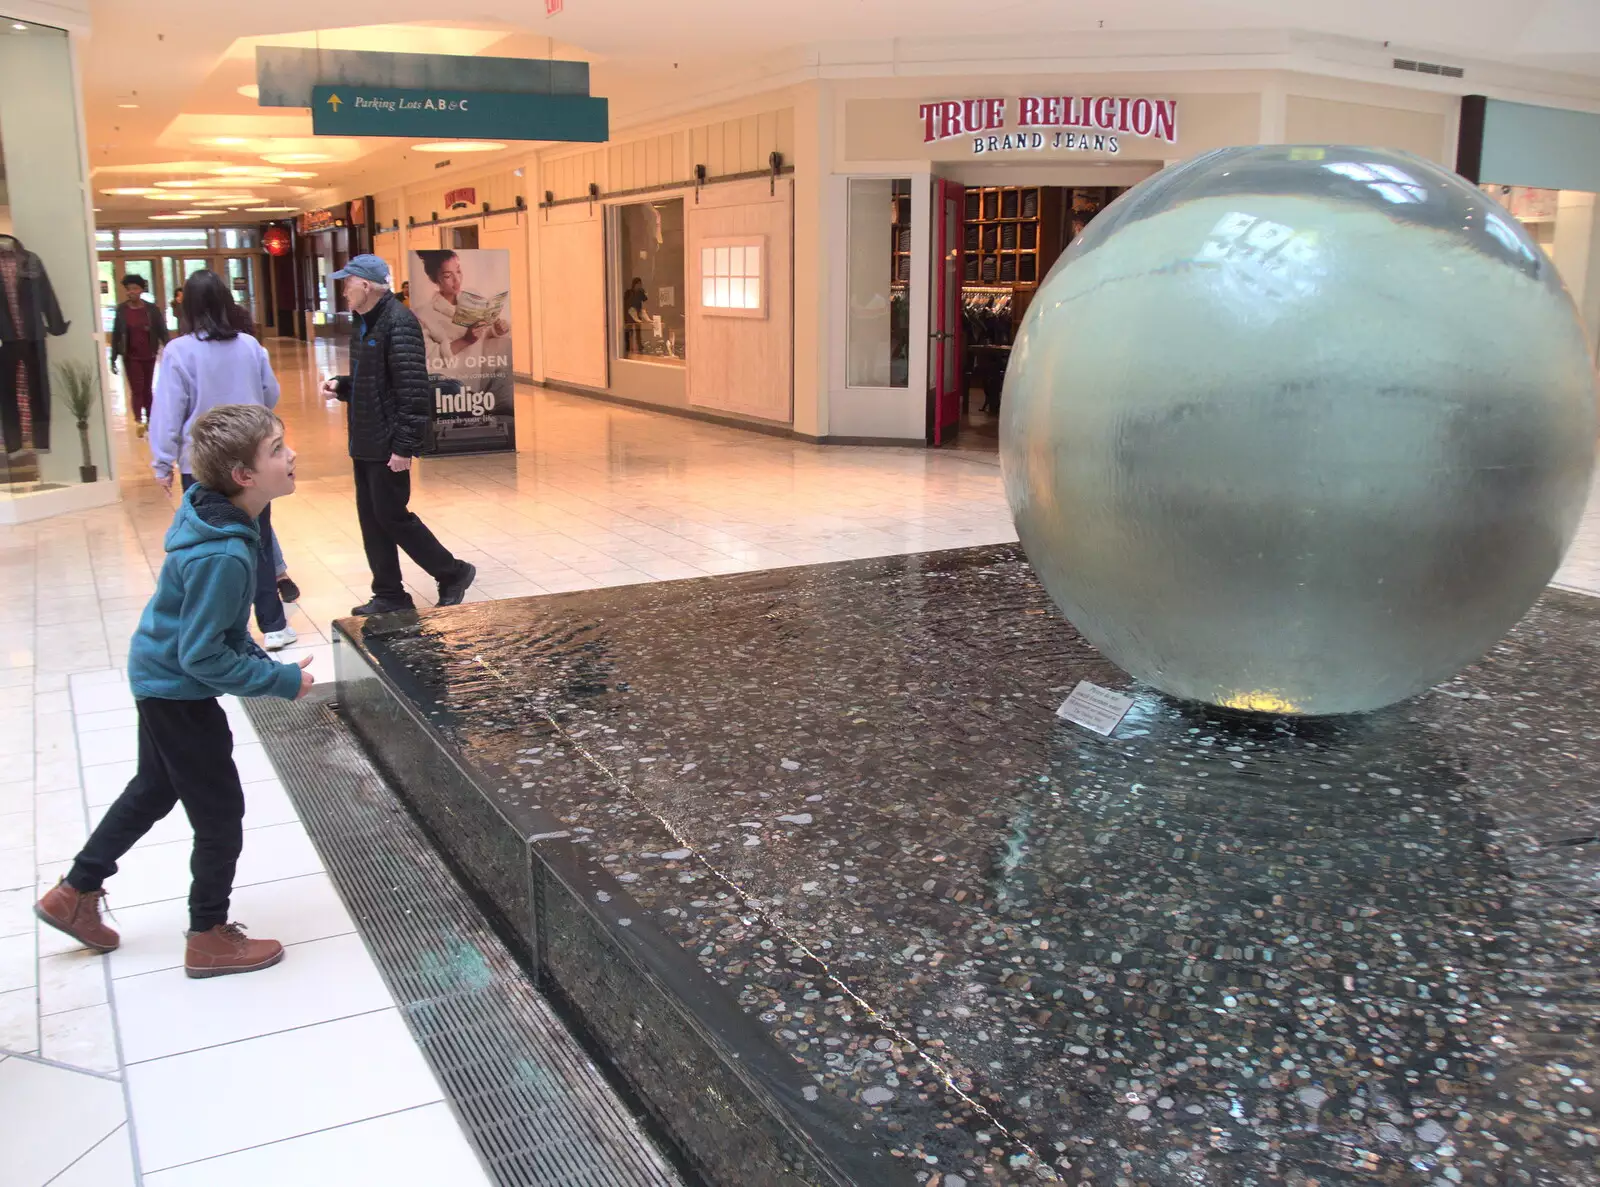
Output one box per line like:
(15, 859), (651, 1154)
(310, 85), (611, 144)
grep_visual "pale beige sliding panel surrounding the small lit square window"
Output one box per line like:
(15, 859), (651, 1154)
(685, 178), (794, 424)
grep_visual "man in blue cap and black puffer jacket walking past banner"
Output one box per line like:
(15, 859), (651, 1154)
(322, 256), (478, 614)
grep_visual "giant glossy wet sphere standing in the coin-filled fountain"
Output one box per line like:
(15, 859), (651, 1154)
(1000, 146), (1597, 713)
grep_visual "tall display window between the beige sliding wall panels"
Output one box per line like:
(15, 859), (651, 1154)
(613, 198), (684, 365)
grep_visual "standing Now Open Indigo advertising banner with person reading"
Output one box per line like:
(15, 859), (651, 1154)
(408, 251), (517, 456)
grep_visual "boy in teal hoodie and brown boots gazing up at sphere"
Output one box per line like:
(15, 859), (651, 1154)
(34, 405), (312, 977)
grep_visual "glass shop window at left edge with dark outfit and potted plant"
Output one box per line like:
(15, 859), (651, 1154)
(0, 5), (117, 523)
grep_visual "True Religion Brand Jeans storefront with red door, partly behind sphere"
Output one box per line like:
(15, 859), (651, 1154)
(818, 72), (1454, 450)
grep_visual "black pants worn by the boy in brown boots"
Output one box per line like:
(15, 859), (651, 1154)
(67, 699), (245, 931)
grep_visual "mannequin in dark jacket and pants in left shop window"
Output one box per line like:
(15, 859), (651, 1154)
(0, 235), (69, 453)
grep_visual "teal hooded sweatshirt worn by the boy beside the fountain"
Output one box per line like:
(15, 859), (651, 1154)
(128, 483), (301, 701)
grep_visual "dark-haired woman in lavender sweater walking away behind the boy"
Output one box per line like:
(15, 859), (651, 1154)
(150, 269), (299, 651)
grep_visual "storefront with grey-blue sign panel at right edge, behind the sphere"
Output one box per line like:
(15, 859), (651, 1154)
(1456, 94), (1600, 358)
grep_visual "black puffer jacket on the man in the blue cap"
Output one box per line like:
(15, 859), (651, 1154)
(338, 293), (434, 462)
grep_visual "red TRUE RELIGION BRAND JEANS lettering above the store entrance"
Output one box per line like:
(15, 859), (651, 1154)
(917, 94), (1178, 157)
